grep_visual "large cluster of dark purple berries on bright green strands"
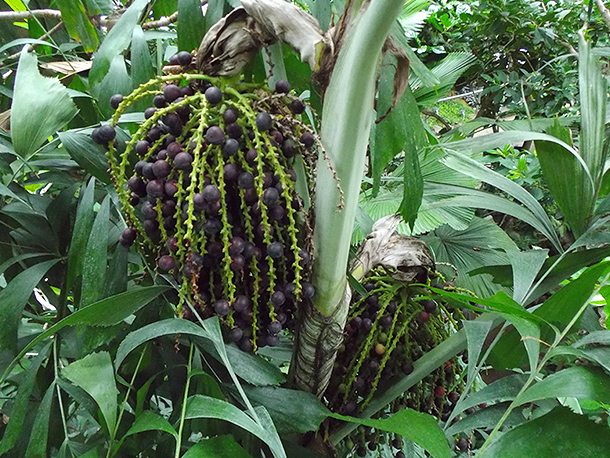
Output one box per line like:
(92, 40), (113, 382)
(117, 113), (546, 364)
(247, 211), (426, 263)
(92, 71), (315, 351)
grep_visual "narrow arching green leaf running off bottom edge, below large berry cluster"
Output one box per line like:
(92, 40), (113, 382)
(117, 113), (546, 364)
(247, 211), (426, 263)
(185, 395), (286, 458)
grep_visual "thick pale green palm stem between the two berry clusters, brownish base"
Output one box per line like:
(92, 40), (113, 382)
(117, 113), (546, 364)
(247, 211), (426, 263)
(291, 0), (403, 396)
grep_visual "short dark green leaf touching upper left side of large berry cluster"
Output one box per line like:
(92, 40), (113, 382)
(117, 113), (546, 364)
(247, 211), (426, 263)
(59, 129), (110, 184)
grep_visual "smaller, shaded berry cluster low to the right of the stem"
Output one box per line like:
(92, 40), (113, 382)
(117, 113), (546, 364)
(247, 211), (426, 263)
(326, 268), (464, 456)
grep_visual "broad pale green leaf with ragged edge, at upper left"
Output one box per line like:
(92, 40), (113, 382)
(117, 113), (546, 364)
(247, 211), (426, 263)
(11, 48), (78, 158)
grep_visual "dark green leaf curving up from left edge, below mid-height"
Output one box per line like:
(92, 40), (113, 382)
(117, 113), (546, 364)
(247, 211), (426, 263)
(0, 259), (58, 354)
